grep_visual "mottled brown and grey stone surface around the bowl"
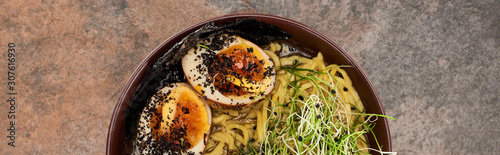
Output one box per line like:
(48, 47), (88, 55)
(0, 0), (500, 154)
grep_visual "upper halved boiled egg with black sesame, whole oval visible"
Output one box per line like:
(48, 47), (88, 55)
(182, 35), (276, 107)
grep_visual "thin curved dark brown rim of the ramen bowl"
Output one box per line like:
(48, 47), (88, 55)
(106, 13), (392, 154)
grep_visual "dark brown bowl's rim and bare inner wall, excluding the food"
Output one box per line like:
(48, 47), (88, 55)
(106, 14), (392, 154)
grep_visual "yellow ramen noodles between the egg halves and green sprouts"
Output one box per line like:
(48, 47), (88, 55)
(201, 43), (367, 155)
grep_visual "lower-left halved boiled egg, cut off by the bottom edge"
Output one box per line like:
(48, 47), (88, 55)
(136, 83), (212, 154)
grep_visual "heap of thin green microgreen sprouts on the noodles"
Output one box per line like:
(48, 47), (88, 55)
(253, 65), (394, 155)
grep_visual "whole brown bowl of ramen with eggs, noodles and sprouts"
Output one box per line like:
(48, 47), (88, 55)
(107, 14), (392, 154)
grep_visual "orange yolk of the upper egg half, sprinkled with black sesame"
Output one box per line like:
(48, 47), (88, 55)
(210, 44), (264, 96)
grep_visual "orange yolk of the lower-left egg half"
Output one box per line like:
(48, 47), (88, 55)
(150, 87), (210, 148)
